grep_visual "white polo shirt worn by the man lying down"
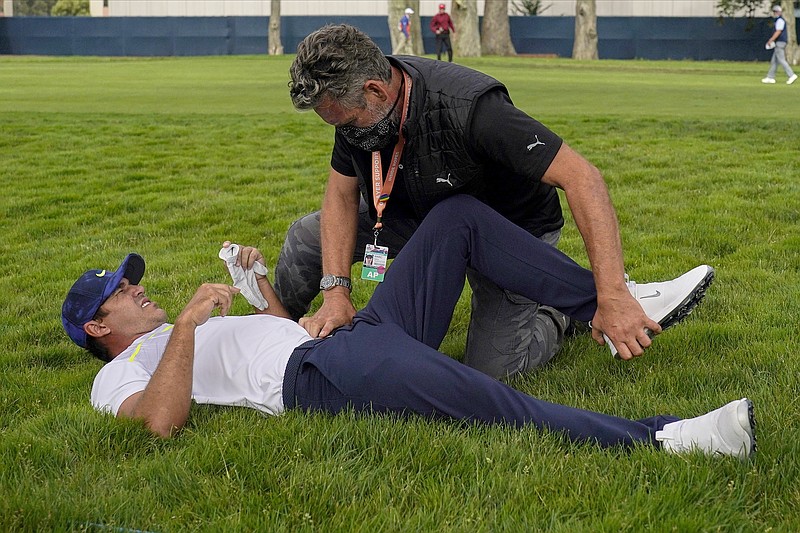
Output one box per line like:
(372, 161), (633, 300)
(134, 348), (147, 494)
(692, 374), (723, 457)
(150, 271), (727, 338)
(92, 315), (311, 416)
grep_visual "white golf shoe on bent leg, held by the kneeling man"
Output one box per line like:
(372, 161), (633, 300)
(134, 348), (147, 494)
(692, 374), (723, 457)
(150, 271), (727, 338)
(603, 265), (714, 356)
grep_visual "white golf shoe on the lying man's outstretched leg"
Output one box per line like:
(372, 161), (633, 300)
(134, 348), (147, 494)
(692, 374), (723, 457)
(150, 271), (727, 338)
(656, 398), (756, 459)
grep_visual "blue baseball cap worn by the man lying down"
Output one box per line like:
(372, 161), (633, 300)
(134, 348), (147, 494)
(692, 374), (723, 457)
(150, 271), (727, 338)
(61, 254), (144, 348)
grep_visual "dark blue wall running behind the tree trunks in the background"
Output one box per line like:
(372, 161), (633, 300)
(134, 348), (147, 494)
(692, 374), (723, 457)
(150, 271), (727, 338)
(0, 16), (771, 61)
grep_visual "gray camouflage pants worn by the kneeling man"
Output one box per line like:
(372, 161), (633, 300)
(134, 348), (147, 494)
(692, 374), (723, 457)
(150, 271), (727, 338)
(275, 200), (569, 379)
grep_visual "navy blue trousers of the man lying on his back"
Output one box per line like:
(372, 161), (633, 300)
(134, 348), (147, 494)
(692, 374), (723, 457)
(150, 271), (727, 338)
(287, 196), (678, 446)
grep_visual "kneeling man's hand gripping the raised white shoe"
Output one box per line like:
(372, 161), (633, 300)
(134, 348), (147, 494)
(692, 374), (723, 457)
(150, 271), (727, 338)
(592, 291), (661, 360)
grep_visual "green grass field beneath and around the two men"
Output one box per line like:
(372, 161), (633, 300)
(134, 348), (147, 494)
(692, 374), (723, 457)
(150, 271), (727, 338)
(0, 57), (800, 532)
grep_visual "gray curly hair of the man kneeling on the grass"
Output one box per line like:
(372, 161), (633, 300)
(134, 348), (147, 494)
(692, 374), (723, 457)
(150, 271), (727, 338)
(289, 24), (392, 109)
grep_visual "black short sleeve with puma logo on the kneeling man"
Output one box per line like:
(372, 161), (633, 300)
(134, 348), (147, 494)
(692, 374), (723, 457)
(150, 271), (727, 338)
(469, 89), (563, 182)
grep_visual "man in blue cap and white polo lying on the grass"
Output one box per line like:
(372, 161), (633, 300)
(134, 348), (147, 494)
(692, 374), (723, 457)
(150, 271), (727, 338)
(62, 196), (755, 458)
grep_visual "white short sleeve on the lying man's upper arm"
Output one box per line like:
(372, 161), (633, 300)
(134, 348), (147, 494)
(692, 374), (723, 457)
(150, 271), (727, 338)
(92, 360), (151, 416)
